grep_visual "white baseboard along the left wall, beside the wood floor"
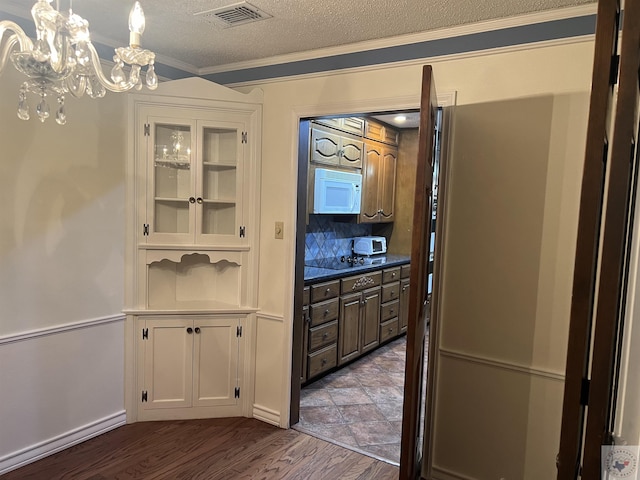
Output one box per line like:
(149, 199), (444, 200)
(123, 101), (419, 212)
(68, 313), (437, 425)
(0, 410), (127, 475)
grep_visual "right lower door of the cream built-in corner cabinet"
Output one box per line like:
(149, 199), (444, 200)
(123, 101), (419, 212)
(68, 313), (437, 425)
(193, 318), (238, 407)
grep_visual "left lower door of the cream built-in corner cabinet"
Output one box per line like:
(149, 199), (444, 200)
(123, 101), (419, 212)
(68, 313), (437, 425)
(140, 319), (193, 409)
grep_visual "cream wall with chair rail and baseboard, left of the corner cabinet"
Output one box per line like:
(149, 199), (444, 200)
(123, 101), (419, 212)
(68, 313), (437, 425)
(0, 68), (126, 474)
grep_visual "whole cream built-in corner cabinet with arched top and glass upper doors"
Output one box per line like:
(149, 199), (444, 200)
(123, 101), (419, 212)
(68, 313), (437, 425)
(127, 79), (262, 420)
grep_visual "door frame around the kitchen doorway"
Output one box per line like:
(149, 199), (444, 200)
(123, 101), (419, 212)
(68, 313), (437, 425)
(285, 91), (457, 427)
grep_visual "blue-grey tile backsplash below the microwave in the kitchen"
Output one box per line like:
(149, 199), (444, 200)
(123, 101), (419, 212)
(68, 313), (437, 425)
(304, 215), (372, 260)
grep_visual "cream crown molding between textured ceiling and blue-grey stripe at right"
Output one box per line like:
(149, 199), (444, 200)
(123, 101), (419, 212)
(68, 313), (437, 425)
(198, 3), (597, 75)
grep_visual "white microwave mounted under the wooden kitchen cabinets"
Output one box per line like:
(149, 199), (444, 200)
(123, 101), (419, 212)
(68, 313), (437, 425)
(313, 168), (362, 213)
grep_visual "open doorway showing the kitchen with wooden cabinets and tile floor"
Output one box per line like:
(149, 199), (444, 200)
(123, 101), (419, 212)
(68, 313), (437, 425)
(290, 109), (443, 464)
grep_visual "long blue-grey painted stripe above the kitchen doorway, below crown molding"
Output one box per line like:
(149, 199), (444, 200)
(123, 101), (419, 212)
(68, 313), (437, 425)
(203, 14), (596, 84)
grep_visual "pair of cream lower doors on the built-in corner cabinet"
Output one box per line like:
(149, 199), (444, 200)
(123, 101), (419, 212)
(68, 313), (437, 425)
(138, 315), (242, 420)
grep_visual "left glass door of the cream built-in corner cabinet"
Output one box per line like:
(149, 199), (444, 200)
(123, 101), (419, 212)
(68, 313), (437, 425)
(147, 120), (196, 240)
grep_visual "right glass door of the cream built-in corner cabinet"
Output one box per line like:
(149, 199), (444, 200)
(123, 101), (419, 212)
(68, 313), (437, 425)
(196, 121), (243, 243)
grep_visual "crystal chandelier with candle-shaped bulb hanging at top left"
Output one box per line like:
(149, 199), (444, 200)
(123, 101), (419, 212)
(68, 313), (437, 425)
(0, 0), (158, 125)
